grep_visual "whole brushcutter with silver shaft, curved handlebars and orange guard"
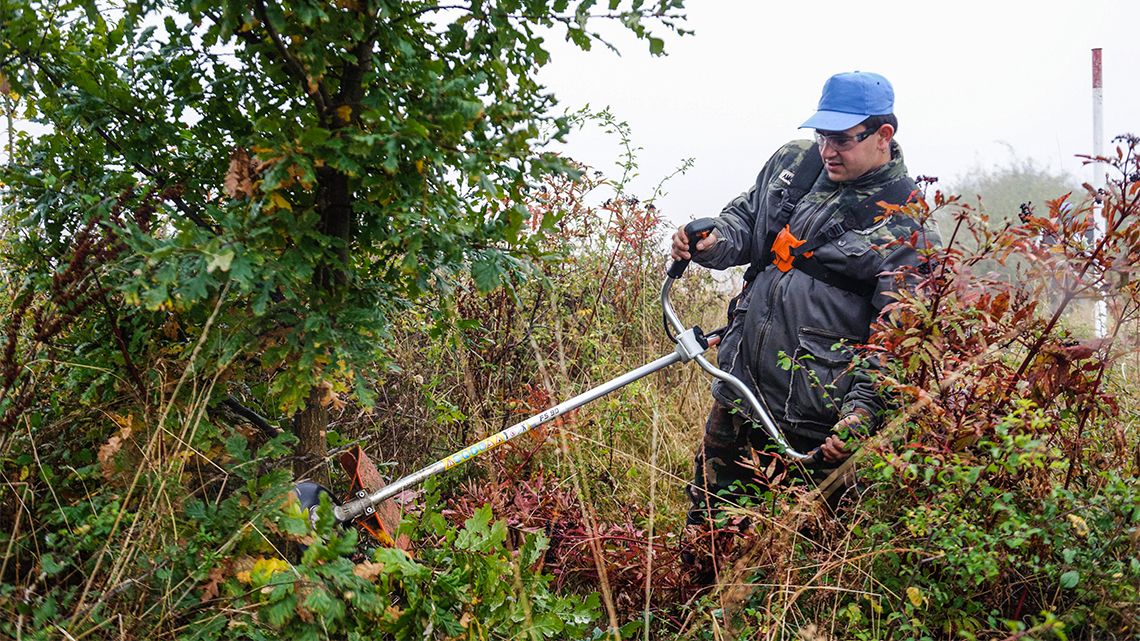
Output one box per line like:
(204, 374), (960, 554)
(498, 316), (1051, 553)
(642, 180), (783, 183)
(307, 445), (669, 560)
(296, 218), (822, 545)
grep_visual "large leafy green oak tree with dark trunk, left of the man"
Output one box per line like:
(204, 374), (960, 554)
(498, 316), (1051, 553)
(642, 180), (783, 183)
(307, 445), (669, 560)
(0, 0), (683, 479)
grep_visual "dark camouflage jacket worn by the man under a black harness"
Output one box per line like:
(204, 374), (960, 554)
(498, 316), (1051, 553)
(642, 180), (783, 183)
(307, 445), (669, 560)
(693, 140), (938, 441)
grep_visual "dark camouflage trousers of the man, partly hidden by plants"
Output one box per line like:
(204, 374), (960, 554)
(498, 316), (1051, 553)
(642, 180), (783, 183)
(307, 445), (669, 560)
(686, 403), (842, 525)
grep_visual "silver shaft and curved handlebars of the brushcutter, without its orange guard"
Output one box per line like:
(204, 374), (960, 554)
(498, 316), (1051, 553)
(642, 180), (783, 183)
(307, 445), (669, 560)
(321, 223), (819, 522)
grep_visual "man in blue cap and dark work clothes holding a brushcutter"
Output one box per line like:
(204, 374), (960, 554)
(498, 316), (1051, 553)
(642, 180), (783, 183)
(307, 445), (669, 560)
(671, 72), (937, 524)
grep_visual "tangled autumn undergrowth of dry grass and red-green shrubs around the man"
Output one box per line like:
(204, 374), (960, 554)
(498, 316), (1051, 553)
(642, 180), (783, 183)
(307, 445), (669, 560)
(0, 131), (1140, 641)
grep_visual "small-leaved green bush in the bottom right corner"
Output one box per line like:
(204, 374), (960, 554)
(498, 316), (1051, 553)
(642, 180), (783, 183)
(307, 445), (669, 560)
(842, 407), (1140, 639)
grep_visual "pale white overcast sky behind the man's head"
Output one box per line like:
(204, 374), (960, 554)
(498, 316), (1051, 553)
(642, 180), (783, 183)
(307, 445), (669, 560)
(540, 0), (1140, 222)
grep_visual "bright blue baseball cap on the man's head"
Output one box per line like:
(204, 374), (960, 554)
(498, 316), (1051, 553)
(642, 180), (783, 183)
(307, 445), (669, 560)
(799, 71), (895, 131)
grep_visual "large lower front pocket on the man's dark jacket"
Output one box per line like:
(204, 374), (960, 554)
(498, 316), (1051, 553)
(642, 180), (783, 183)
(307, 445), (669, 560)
(784, 327), (857, 429)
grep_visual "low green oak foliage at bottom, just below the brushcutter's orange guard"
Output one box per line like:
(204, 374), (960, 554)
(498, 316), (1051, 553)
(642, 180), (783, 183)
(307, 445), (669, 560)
(193, 479), (600, 640)
